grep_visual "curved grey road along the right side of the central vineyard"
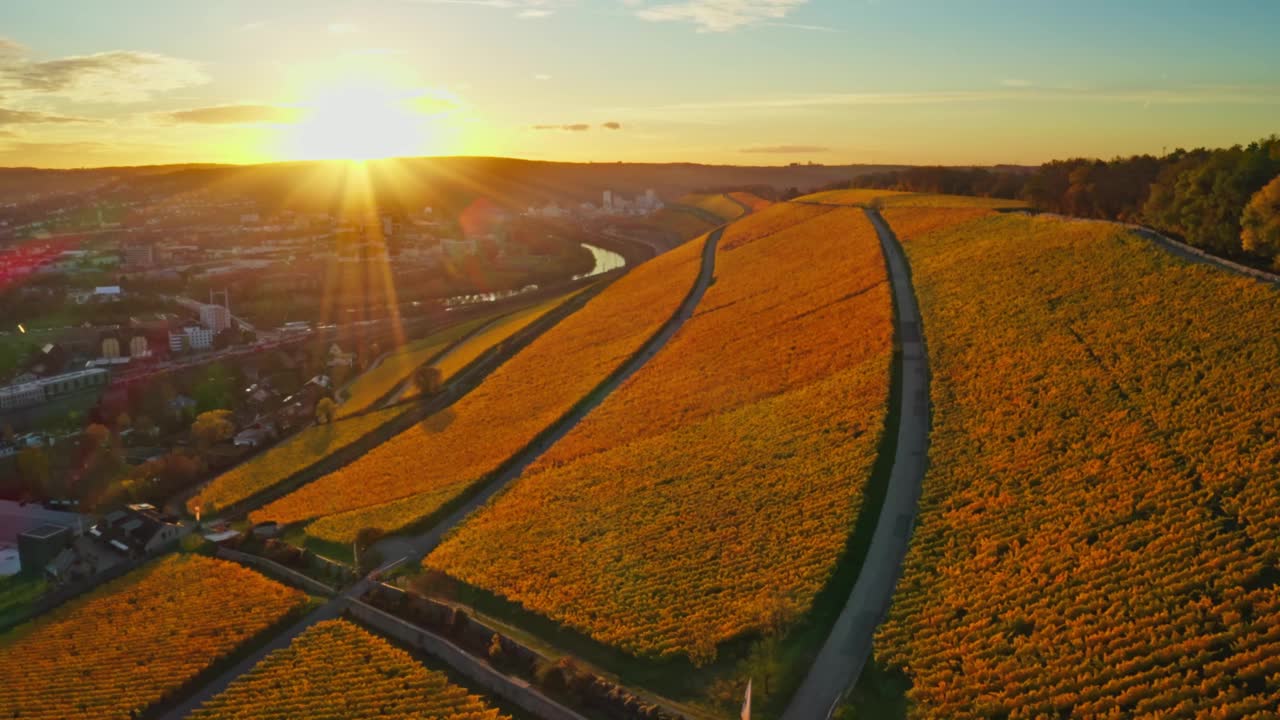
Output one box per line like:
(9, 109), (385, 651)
(782, 210), (929, 720)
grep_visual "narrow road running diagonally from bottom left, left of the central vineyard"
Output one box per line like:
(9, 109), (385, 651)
(160, 228), (723, 720)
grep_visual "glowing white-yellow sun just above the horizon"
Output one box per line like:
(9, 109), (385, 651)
(285, 79), (448, 160)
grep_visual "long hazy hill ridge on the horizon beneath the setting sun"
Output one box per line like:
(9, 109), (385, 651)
(0, 158), (926, 219)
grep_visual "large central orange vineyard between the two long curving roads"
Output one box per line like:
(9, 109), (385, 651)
(425, 197), (892, 665)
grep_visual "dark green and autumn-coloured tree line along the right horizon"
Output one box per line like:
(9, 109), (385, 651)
(828, 135), (1280, 268)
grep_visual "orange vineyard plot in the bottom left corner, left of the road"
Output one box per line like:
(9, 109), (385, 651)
(0, 555), (307, 720)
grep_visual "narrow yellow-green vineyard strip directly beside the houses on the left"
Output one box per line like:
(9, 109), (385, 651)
(187, 407), (404, 516)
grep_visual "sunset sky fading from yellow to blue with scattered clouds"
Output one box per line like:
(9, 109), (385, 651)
(0, 0), (1280, 167)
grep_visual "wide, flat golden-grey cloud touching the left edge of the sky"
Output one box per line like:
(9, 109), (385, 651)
(0, 42), (209, 102)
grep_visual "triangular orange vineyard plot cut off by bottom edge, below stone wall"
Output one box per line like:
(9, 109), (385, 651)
(188, 620), (507, 720)
